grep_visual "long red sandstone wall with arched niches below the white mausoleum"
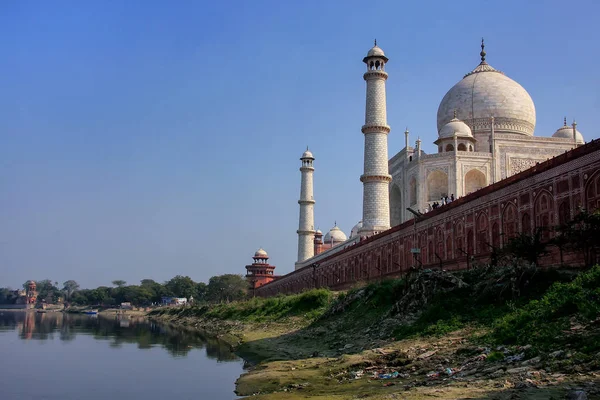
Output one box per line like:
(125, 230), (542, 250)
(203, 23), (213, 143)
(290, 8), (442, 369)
(256, 140), (600, 296)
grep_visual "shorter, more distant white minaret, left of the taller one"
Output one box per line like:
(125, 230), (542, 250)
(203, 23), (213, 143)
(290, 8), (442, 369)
(297, 147), (315, 262)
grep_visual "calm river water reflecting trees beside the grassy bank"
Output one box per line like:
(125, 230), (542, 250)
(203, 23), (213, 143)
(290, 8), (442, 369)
(0, 310), (244, 400)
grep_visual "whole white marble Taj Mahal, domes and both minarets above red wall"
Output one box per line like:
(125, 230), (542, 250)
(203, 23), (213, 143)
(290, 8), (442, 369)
(247, 40), (585, 284)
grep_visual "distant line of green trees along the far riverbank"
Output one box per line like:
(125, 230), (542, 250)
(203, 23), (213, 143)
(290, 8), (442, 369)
(0, 274), (248, 306)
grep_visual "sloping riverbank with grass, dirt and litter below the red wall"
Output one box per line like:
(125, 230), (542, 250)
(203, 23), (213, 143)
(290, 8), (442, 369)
(150, 267), (600, 399)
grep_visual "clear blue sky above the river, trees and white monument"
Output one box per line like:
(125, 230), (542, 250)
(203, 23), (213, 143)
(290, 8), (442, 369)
(0, 0), (600, 287)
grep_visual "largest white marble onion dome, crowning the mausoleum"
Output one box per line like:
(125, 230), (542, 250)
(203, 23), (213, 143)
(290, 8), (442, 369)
(437, 57), (536, 136)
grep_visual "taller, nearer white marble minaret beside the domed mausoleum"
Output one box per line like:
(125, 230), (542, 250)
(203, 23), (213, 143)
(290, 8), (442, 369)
(359, 41), (392, 236)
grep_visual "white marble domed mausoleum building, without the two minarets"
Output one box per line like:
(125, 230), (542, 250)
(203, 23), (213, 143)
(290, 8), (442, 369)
(388, 42), (583, 226)
